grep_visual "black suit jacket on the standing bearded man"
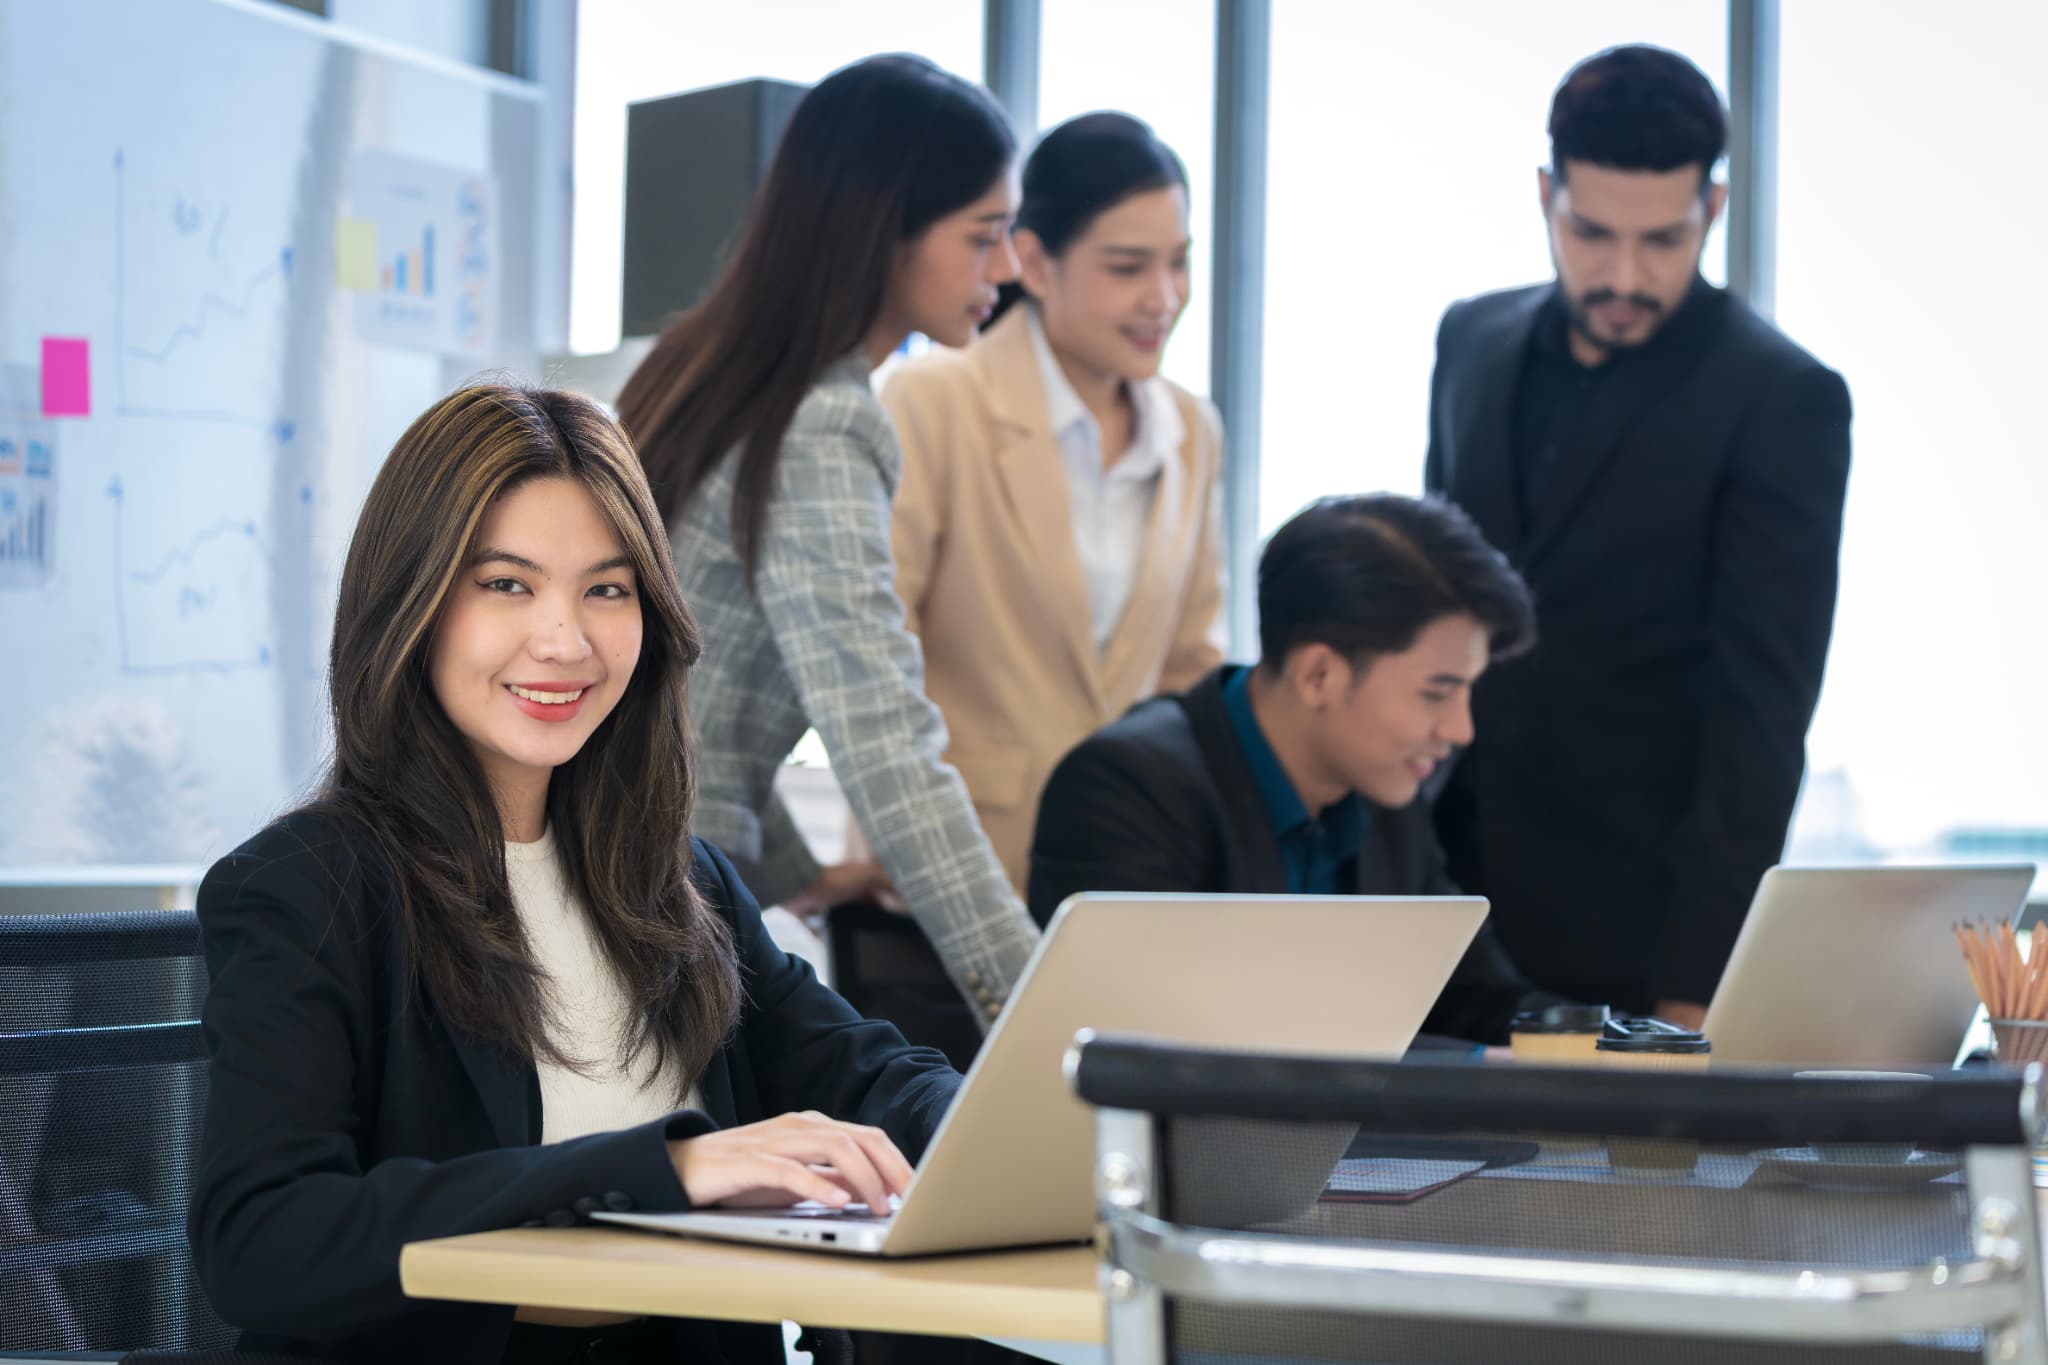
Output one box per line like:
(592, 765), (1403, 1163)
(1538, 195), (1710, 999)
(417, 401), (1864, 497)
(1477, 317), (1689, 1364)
(1425, 282), (1849, 1007)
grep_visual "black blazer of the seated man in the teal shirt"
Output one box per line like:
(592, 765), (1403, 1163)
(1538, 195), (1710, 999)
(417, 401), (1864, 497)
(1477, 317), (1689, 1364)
(1030, 665), (1561, 1044)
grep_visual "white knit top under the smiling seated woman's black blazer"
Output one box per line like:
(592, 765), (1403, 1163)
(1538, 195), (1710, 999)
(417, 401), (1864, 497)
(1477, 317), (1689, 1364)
(506, 829), (698, 1142)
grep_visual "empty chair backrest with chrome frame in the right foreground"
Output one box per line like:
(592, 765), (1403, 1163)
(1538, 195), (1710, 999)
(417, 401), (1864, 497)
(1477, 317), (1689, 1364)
(1069, 1036), (2048, 1365)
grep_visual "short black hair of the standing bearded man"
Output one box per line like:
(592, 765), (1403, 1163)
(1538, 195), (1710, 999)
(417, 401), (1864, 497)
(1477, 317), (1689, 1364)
(1550, 43), (1729, 190)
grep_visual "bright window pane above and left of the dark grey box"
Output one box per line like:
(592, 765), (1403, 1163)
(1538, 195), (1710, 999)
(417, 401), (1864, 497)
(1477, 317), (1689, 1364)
(569, 0), (981, 352)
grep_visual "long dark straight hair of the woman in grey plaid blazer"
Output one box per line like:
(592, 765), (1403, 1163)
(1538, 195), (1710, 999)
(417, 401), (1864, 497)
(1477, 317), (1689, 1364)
(618, 55), (1016, 573)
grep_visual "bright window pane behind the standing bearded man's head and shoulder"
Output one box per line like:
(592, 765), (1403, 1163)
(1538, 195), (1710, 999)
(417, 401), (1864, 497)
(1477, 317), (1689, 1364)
(1260, 0), (1728, 530)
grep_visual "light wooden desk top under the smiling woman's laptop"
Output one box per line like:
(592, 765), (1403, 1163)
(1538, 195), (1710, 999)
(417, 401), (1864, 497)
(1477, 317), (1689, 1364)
(397, 1228), (1102, 1345)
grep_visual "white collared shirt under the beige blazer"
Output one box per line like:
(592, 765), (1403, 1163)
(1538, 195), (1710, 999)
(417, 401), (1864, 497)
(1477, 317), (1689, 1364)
(1024, 303), (1188, 653)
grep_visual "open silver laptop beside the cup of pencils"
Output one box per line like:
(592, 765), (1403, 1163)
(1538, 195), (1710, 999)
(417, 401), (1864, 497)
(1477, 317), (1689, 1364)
(1706, 864), (2034, 1070)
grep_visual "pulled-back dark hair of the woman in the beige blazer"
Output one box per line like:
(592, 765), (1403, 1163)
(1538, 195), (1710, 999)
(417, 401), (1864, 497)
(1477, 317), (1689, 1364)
(989, 111), (1188, 323)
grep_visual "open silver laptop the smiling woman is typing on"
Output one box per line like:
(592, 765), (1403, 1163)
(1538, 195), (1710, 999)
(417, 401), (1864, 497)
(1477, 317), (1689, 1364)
(596, 894), (1487, 1257)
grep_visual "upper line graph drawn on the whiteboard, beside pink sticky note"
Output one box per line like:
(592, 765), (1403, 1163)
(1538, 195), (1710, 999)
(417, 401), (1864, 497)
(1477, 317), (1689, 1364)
(113, 147), (297, 444)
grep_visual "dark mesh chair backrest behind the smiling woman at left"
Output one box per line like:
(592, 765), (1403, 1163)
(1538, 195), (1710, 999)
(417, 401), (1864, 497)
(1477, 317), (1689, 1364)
(0, 911), (236, 1351)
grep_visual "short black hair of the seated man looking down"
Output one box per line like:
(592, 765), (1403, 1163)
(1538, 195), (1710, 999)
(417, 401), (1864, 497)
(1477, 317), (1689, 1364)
(1260, 493), (1536, 669)
